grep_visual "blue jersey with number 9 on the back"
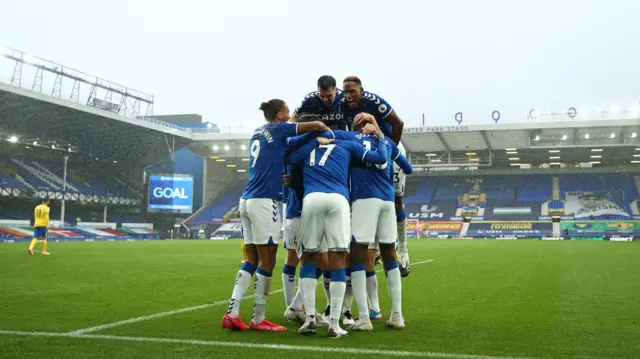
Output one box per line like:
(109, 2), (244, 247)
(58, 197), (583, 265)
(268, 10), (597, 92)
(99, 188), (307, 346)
(242, 122), (298, 201)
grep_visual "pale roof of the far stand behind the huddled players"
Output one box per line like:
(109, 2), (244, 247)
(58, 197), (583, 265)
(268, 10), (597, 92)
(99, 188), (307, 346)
(186, 114), (640, 168)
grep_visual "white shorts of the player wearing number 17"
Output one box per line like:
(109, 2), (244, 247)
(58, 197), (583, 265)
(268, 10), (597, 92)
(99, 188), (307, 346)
(300, 192), (351, 252)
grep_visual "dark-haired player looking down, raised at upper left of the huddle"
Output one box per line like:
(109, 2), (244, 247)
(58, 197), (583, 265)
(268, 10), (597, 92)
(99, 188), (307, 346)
(293, 75), (351, 131)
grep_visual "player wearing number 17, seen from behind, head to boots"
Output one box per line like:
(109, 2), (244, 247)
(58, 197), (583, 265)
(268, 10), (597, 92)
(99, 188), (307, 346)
(289, 124), (387, 338)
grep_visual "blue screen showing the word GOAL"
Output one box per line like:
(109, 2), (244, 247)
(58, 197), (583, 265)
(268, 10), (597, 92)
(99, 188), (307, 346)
(147, 174), (193, 214)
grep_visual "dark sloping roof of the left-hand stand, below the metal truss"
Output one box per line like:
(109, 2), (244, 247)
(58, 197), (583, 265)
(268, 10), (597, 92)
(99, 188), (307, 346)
(0, 82), (191, 165)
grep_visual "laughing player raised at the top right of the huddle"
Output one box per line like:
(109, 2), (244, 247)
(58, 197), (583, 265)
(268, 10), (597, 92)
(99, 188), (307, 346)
(340, 76), (411, 277)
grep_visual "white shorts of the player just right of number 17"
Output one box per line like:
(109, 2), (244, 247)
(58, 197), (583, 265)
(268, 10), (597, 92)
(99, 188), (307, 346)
(351, 198), (398, 249)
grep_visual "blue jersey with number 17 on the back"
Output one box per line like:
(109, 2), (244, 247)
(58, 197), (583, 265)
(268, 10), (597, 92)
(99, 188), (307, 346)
(296, 139), (387, 201)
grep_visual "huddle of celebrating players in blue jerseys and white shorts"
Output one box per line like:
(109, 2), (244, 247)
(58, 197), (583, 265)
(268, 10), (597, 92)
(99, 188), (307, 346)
(222, 76), (412, 338)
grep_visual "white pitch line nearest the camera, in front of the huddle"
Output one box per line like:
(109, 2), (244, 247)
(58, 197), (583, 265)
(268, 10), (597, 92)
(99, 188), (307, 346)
(0, 330), (528, 359)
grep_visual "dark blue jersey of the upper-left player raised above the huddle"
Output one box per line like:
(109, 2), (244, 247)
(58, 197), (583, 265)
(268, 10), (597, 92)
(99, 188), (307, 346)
(293, 89), (351, 131)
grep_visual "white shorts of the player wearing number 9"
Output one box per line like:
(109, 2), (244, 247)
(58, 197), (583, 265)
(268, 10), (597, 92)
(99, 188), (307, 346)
(240, 198), (280, 245)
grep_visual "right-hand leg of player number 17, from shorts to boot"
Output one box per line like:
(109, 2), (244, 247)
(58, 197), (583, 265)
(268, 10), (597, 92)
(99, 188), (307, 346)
(324, 193), (351, 338)
